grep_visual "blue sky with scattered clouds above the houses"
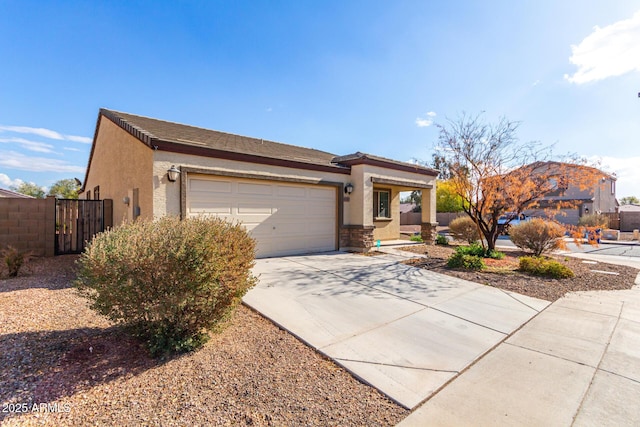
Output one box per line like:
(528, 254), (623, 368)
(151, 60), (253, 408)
(0, 0), (640, 197)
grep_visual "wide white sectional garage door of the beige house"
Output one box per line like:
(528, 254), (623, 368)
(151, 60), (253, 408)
(187, 175), (337, 257)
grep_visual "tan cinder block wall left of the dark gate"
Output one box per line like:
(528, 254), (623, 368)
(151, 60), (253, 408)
(0, 197), (56, 256)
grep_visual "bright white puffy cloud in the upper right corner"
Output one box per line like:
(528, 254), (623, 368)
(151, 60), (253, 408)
(564, 12), (640, 84)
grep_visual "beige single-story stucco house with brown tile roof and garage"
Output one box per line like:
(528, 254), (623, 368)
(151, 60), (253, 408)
(80, 109), (437, 257)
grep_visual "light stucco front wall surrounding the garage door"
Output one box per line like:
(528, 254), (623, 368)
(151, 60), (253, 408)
(153, 151), (352, 224)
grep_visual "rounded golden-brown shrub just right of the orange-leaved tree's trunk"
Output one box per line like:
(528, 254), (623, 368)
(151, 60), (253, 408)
(509, 218), (565, 256)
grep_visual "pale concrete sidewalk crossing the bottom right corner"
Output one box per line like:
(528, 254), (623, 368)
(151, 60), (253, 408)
(399, 281), (640, 427)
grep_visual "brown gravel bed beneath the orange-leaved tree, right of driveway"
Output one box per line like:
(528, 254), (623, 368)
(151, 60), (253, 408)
(400, 245), (638, 301)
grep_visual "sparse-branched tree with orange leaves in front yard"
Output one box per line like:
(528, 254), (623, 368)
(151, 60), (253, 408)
(436, 113), (602, 254)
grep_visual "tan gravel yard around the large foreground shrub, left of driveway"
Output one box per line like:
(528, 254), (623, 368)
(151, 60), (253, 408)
(0, 255), (408, 426)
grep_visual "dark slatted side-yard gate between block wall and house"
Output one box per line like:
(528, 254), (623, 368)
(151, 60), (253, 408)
(56, 199), (104, 255)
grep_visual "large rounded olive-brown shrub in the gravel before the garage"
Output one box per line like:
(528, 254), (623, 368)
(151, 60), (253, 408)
(75, 217), (256, 356)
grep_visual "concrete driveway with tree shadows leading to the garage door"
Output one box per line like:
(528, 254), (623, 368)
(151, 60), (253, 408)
(244, 253), (549, 408)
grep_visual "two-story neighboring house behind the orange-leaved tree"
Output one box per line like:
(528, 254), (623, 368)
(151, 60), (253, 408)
(524, 162), (618, 225)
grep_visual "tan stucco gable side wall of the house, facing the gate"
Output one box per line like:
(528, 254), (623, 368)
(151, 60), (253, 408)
(80, 116), (153, 225)
